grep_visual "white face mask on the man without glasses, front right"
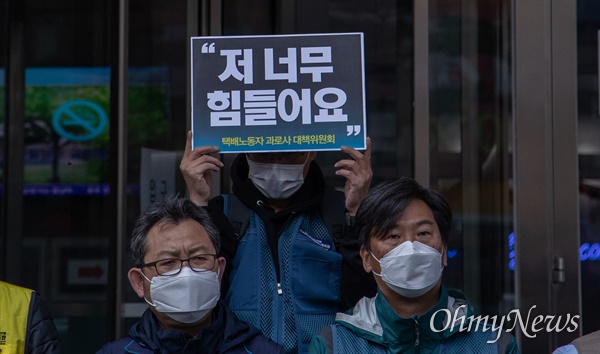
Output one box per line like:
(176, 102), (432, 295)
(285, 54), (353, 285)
(371, 241), (444, 297)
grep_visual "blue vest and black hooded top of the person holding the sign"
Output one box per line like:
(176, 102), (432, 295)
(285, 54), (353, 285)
(208, 154), (376, 354)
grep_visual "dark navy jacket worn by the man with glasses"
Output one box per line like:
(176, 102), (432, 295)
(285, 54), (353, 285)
(97, 301), (281, 354)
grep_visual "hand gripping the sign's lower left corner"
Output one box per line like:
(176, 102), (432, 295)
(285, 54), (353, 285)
(179, 131), (223, 206)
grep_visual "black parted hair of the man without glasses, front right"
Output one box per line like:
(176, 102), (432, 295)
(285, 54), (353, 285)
(355, 177), (452, 250)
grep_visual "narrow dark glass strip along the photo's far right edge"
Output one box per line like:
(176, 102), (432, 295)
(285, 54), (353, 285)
(577, 0), (600, 334)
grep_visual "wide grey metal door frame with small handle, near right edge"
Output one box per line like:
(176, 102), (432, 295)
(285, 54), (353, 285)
(512, 0), (587, 353)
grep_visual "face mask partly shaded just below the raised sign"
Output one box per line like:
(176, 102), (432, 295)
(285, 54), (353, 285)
(246, 154), (308, 199)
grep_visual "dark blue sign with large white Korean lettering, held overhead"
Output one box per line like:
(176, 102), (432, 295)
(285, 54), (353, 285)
(191, 33), (367, 153)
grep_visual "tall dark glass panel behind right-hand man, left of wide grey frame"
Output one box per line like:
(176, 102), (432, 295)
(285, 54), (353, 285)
(429, 1), (518, 315)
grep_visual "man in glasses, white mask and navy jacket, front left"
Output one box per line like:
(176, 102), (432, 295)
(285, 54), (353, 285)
(98, 198), (281, 353)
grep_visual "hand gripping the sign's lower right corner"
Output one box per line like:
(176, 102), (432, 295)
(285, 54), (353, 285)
(334, 138), (373, 215)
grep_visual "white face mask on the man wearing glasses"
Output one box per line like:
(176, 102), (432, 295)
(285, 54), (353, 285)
(142, 267), (221, 323)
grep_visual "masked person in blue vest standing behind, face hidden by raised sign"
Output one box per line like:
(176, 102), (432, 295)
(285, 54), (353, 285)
(180, 132), (376, 353)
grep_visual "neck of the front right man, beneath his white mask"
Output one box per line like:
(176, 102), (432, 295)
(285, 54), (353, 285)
(381, 281), (442, 318)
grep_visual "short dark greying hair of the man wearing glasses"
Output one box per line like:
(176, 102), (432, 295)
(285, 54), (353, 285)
(130, 196), (221, 266)
